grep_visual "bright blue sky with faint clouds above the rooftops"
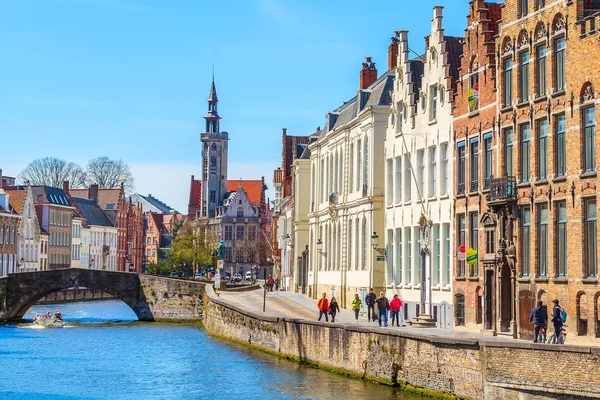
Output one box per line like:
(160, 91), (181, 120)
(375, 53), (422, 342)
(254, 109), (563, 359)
(0, 0), (468, 212)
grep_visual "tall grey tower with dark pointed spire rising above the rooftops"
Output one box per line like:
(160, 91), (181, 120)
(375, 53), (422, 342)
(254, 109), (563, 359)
(200, 74), (229, 218)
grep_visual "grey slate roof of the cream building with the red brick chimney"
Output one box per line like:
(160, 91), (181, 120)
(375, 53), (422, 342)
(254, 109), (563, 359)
(330, 70), (394, 131)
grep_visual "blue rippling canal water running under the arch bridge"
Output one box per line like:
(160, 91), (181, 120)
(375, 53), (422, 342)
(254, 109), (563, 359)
(0, 300), (418, 400)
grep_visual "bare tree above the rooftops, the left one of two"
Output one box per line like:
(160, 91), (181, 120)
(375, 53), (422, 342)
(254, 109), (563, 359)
(18, 157), (87, 188)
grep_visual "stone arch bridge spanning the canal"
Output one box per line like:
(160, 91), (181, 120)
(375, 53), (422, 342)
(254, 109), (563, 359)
(0, 268), (205, 322)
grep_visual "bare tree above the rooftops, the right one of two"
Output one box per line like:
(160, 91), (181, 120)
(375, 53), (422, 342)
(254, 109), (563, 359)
(87, 157), (135, 193)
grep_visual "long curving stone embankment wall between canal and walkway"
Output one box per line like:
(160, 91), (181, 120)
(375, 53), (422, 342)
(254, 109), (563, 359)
(204, 285), (600, 400)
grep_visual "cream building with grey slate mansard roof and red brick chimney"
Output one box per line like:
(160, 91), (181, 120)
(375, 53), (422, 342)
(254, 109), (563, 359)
(308, 61), (394, 308)
